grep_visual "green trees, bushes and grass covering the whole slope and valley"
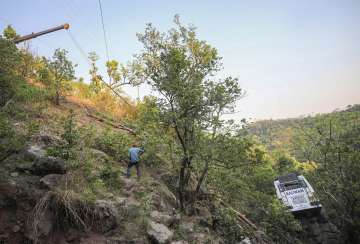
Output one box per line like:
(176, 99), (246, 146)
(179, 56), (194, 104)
(0, 17), (360, 243)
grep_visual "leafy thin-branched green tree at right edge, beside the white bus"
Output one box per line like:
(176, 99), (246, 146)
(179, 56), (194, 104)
(303, 113), (360, 243)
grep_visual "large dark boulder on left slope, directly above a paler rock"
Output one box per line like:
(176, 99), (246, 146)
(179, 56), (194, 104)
(30, 157), (66, 176)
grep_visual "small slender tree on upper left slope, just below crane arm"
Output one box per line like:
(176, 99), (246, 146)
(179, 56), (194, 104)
(48, 48), (75, 105)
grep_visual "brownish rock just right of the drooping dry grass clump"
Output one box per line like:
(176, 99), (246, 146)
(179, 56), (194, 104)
(92, 200), (119, 233)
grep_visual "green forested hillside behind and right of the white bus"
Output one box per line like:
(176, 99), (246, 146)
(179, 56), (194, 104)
(247, 105), (360, 243)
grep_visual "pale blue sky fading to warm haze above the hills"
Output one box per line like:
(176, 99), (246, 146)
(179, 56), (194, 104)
(0, 0), (360, 120)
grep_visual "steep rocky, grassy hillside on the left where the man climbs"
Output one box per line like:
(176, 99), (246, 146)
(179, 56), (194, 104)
(0, 90), (272, 244)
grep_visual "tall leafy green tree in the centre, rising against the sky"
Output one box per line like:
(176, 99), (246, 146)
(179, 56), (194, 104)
(135, 16), (242, 209)
